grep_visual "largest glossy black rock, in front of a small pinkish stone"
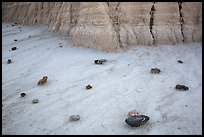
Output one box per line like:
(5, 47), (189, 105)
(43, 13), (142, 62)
(125, 115), (149, 127)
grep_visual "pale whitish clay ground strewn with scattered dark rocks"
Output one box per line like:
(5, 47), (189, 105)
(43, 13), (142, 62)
(2, 23), (202, 135)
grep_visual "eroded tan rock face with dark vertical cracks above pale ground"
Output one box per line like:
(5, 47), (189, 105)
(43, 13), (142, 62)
(2, 2), (202, 51)
